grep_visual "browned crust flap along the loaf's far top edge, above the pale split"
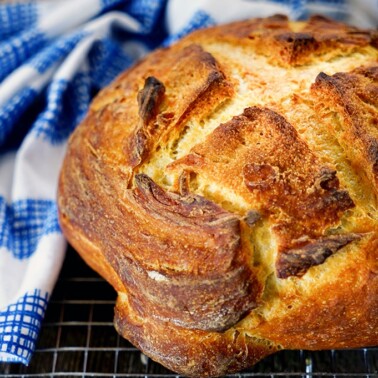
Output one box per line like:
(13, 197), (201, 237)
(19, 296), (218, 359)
(187, 15), (378, 66)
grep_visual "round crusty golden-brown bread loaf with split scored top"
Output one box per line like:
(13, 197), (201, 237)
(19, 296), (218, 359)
(58, 16), (378, 377)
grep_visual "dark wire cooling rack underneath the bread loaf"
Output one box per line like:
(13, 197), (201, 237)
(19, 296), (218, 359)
(0, 248), (378, 378)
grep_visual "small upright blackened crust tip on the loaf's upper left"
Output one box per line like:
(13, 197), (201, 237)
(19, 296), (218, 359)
(138, 76), (165, 124)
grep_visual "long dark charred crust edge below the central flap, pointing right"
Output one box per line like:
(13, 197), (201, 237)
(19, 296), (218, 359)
(276, 234), (362, 278)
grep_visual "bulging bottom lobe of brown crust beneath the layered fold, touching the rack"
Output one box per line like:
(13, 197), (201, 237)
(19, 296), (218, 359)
(114, 290), (278, 377)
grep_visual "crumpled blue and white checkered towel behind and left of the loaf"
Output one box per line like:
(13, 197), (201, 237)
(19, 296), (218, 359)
(0, 0), (378, 364)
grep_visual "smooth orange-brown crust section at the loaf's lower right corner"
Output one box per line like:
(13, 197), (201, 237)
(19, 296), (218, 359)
(252, 234), (378, 350)
